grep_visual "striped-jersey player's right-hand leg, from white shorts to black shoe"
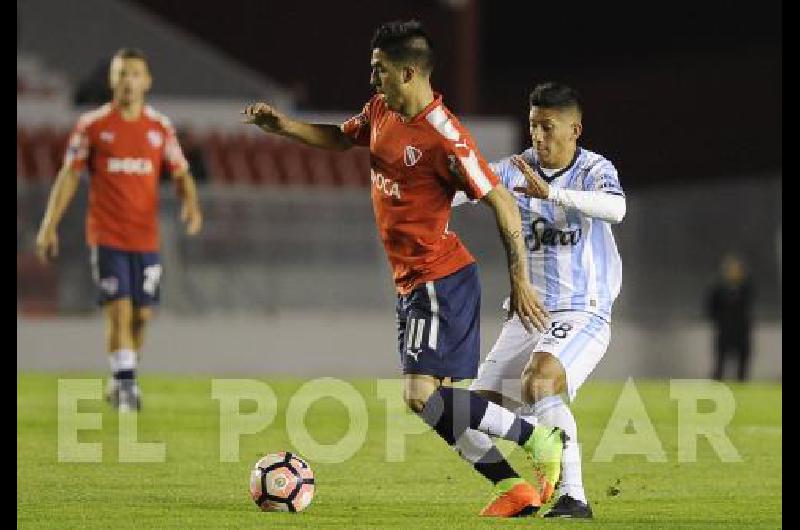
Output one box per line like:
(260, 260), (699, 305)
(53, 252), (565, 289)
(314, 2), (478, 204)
(521, 312), (610, 517)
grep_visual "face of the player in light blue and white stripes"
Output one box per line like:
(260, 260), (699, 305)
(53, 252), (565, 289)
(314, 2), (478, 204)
(528, 107), (582, 169)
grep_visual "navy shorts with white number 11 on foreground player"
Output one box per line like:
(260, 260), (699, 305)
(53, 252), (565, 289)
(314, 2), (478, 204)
(397, 263), (481, 381)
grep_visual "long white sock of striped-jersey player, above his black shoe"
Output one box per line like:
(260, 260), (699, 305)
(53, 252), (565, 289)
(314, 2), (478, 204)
(520, 396), (586, 502)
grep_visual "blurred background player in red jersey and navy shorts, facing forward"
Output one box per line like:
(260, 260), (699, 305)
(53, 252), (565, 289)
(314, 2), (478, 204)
(36, 48), (202, 410)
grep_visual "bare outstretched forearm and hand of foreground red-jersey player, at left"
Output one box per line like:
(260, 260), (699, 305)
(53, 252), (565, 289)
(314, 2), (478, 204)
(242, 103), (353, 151)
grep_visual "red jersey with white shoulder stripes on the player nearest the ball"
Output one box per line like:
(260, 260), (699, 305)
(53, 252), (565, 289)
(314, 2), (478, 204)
(342, 94), (498, 294)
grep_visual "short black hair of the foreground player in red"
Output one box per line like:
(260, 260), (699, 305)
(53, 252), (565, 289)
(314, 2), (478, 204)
(371, 20), (434, 73)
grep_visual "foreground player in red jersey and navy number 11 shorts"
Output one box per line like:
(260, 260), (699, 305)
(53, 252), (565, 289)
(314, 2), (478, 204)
(243, 21), (565, 517)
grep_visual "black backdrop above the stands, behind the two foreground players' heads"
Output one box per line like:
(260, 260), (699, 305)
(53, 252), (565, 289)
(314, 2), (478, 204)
(136, 0), (782, 188)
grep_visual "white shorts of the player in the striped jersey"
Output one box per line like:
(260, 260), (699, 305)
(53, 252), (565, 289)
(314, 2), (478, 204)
(470, 311), (611, 403)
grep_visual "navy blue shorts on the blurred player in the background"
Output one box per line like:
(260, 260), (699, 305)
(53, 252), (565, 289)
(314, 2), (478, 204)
(91, 245), (161, 306)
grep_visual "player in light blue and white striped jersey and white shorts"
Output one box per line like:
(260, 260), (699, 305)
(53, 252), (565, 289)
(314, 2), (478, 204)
(454, 83), (626, 518)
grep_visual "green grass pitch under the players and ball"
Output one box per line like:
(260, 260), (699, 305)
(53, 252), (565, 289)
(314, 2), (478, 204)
(17, 374), (782, 529)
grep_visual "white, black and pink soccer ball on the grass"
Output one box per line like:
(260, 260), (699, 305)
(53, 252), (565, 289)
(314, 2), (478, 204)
(250, 451), (314, 512)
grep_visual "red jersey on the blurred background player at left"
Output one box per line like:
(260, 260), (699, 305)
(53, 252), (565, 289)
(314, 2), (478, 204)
(64, 103), (189, 252)
